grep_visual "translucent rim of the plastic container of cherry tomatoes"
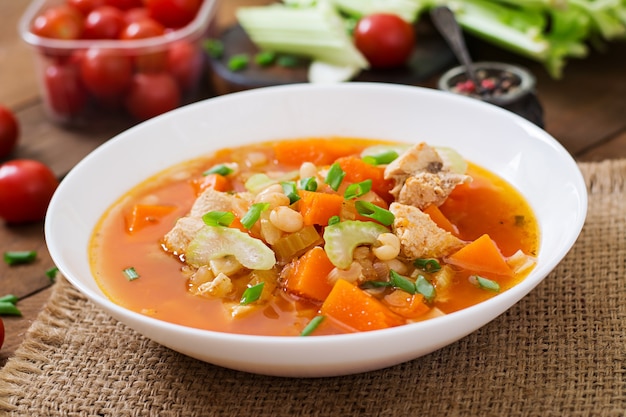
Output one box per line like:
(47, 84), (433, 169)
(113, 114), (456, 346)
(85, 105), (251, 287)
(18, 0), (219, 53)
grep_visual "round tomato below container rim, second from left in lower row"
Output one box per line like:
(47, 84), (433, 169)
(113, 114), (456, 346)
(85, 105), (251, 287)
(80, 48), (133, 99)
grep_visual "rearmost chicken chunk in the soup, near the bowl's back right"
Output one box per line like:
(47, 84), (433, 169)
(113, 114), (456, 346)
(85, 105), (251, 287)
(385, 143), (469, 209)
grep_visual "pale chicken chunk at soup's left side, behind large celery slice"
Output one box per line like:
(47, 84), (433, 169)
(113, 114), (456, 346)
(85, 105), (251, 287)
(163, 188), (250, 255)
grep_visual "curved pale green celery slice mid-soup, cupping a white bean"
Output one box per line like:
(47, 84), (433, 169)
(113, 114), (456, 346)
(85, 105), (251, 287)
(324, 220), (389, 269)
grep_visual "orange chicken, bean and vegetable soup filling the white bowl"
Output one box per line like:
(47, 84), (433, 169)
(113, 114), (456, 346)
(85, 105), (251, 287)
(89, 137), (539, 336)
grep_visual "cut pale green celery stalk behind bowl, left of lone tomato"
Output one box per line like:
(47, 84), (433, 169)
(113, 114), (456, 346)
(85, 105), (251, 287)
(237, 1), (369, 69)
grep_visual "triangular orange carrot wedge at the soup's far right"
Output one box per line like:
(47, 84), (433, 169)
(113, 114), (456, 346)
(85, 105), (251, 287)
(446, 234), (513, 277)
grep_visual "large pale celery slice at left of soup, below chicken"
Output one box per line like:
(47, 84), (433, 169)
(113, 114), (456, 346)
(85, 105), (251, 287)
(185, 226), (276, 270)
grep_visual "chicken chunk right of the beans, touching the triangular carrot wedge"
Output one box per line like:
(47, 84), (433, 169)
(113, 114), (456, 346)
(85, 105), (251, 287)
(389, 203), (465, 259)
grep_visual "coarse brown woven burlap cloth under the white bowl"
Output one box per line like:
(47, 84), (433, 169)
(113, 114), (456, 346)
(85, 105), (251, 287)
(0, 160), (626, 417)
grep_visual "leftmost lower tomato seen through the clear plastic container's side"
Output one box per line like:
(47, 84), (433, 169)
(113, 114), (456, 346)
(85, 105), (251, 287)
(44, 63), (88, 117)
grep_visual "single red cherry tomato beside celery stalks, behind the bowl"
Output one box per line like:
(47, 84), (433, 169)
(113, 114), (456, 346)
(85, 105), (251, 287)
(354, 13), (415, 68)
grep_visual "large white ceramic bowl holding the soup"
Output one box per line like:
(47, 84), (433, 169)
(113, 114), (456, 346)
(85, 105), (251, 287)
(45, 83), (587, 377)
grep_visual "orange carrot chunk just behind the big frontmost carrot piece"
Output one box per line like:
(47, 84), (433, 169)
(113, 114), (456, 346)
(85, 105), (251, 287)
(285, 246), (335, 302)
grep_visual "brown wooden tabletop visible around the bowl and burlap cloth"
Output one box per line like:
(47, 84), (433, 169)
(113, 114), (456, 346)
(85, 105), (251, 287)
(0, 0), (626, 366)
